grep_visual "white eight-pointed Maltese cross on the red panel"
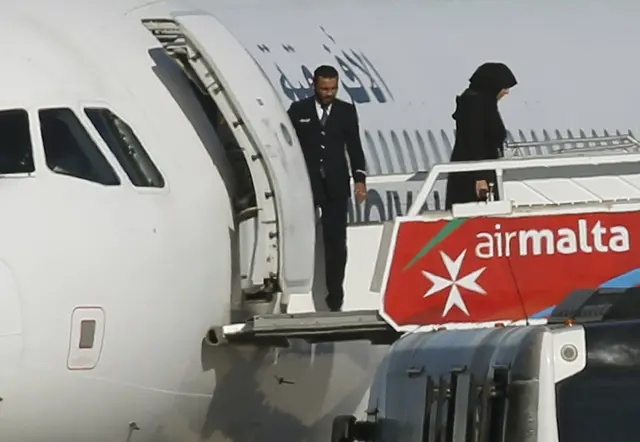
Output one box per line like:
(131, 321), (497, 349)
(422, 249), (487, 318)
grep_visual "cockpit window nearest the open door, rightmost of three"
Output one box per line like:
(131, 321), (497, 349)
(85, 108), (164, 187)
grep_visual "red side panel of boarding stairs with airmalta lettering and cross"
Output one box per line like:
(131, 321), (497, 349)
(384, 212), (640, 325)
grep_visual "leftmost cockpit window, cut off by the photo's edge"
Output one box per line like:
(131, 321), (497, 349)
(0, 109), (35, 174)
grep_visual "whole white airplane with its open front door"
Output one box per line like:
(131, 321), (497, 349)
(0, 0), (640, 442)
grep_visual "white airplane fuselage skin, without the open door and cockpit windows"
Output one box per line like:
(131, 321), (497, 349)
(0, 0), (640, 442)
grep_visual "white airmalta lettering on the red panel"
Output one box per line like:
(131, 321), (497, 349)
(476, 219), (629, 259)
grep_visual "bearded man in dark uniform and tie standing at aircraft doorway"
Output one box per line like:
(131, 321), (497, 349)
(288, 66), (367, 311)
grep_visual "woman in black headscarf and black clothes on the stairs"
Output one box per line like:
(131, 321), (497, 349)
(445, 63), (518, 210)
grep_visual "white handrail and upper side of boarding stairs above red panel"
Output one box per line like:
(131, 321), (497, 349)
(407, 135), (640, 217)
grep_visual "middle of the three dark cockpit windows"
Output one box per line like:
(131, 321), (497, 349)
(39, 108), (120, 186)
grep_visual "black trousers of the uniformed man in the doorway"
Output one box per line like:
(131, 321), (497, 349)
(320, 198), (349, 308)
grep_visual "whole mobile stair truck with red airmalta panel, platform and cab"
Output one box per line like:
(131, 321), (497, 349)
(221, 135), (640, 442)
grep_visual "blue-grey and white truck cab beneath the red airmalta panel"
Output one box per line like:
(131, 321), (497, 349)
(332, 288), (640, 442)
